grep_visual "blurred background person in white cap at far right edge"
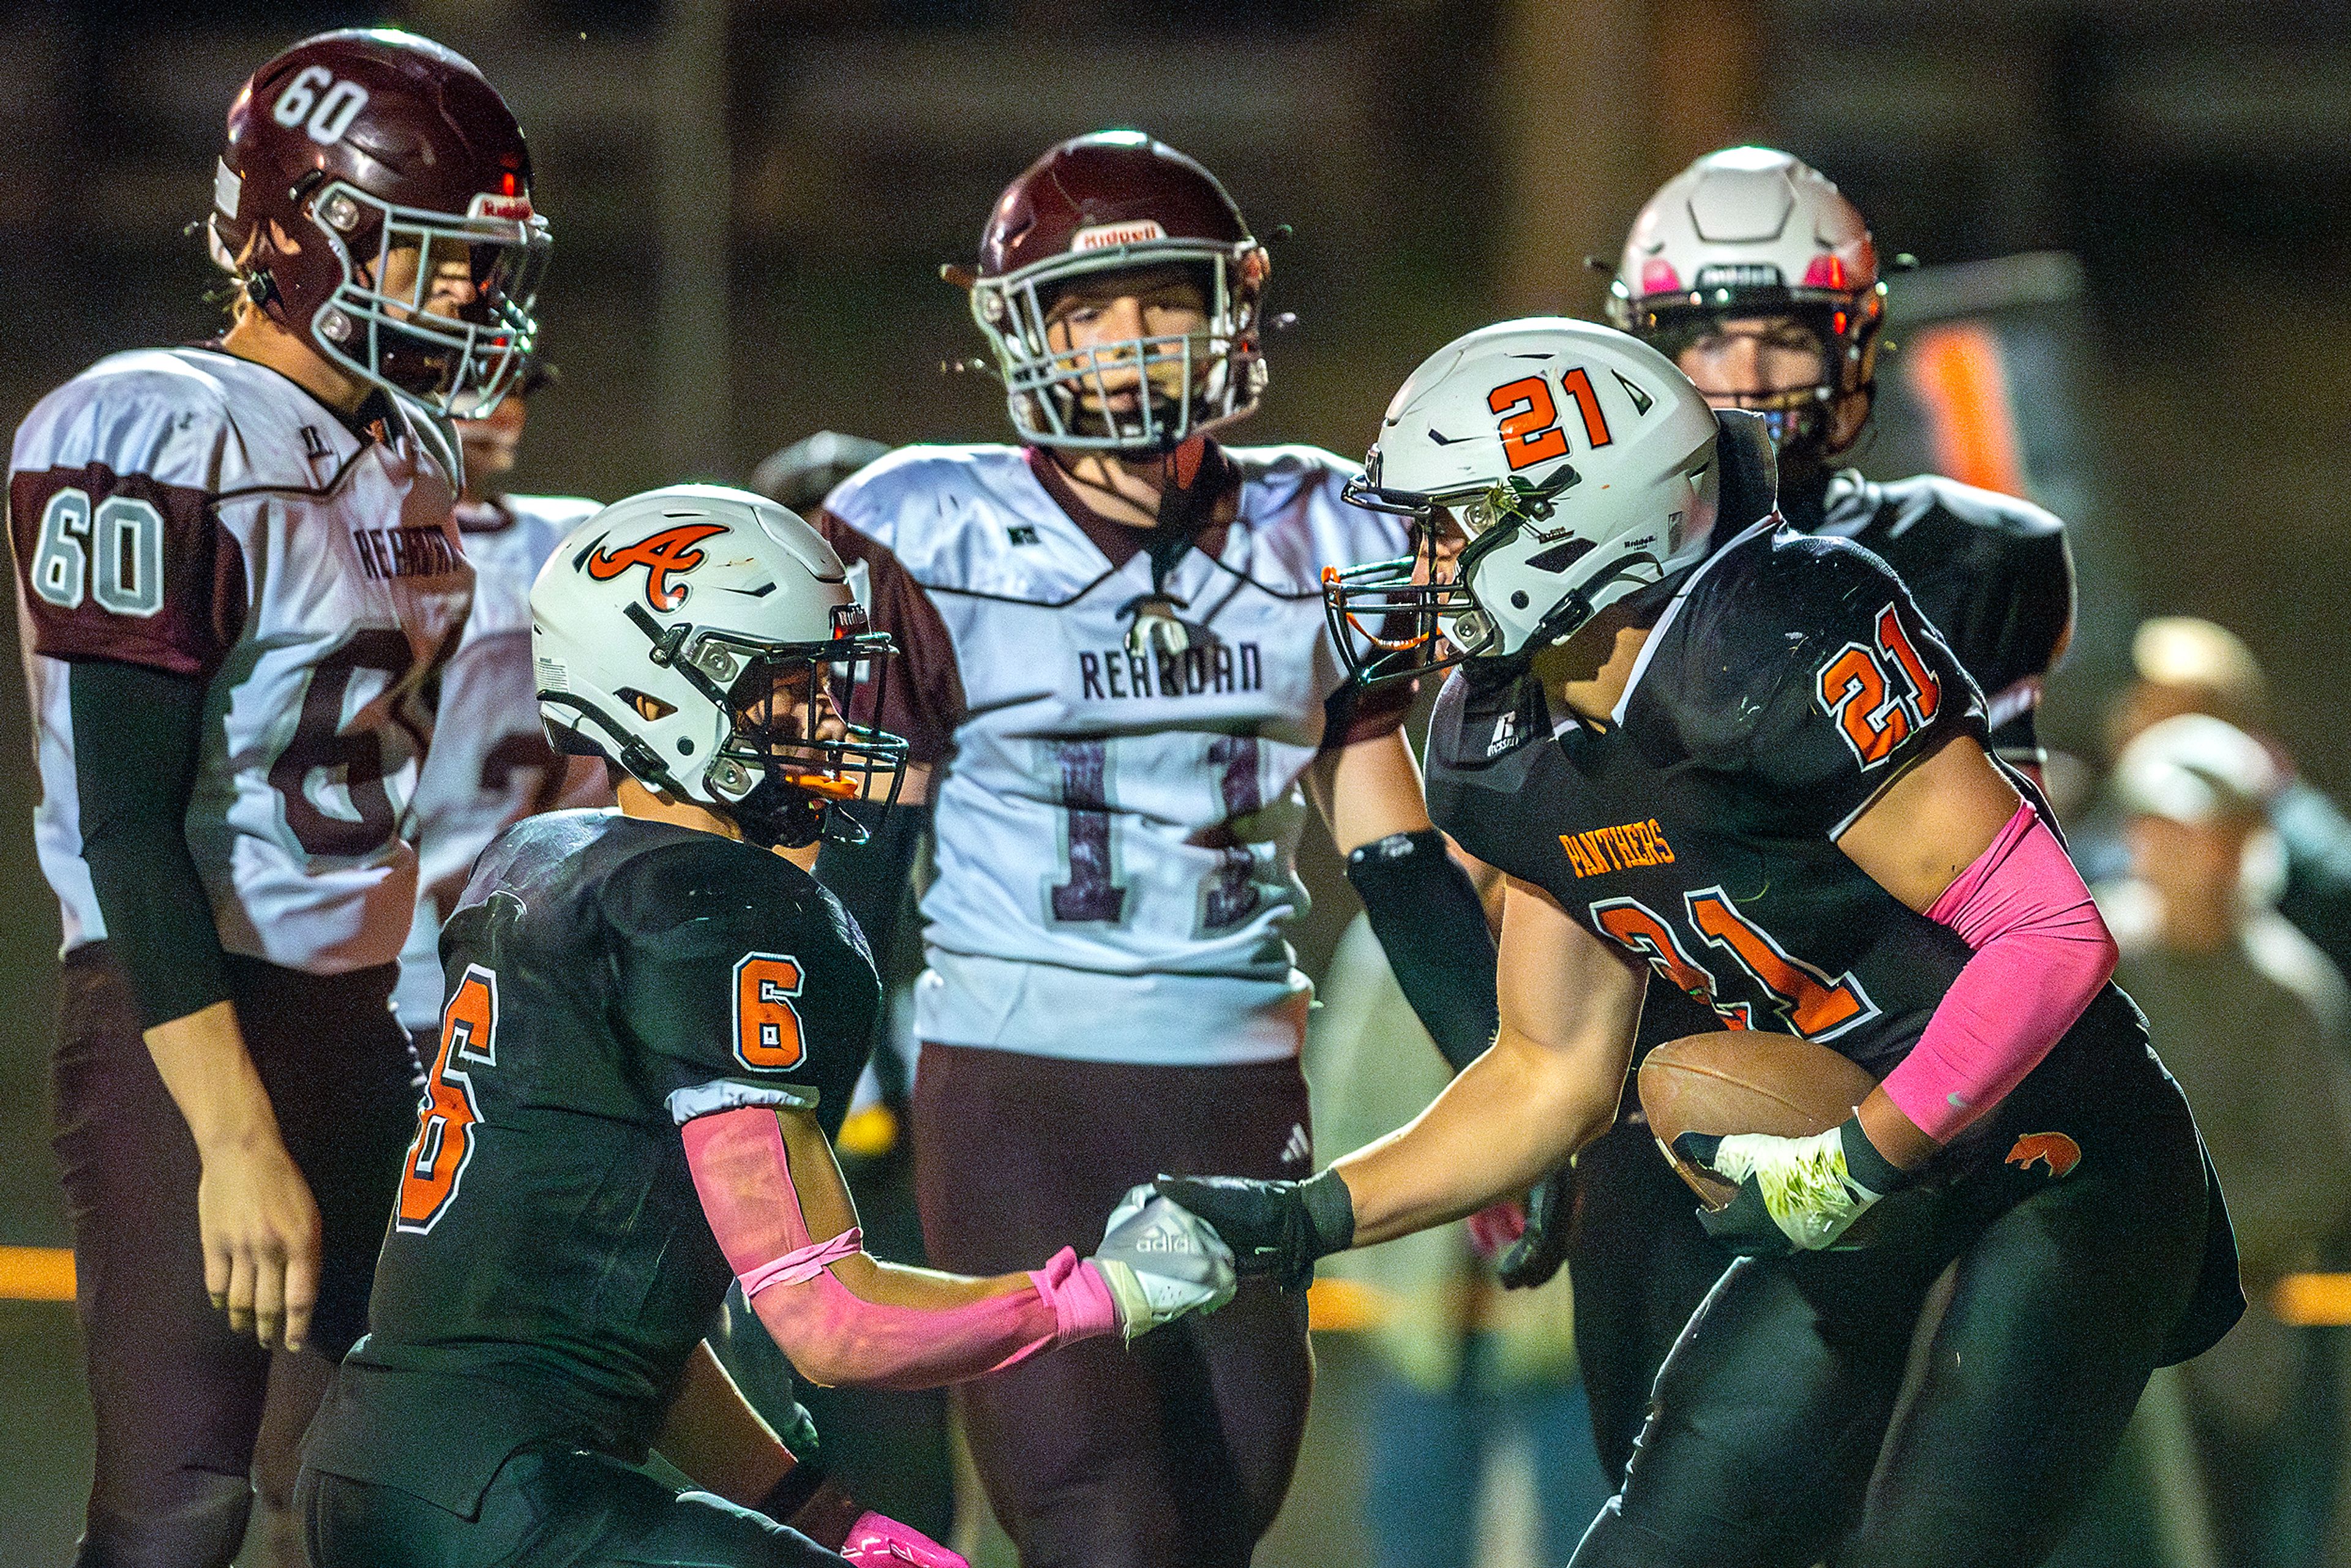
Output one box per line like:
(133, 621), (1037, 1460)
(2097, 715), (2351, 1568)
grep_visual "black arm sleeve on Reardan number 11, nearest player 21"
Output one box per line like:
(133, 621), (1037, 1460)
(1347, 828), (1500, 1072)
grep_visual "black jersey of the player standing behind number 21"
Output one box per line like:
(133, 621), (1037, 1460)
(1780, 468), (2074, 762)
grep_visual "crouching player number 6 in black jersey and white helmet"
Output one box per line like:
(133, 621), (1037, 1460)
(296, 484), (1232, 1568)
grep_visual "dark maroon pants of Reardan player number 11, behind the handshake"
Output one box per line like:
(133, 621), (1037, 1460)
(915, 1044), (1314, 1568)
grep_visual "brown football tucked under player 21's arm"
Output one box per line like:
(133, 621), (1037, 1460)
(1641, 1030), (1876, 1209)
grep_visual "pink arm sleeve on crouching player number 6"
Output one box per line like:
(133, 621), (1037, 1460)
(682, 1105), (1119, 1389)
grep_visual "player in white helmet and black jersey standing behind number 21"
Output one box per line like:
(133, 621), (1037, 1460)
(1500, 148), (2074, 1479)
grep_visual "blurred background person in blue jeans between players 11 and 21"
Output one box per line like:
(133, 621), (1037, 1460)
(1307, 917), (1617, 1568)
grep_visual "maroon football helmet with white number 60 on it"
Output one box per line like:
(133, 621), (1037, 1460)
(209, 28), (548, 416)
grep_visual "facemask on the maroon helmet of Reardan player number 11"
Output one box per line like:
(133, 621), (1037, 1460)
(971, 240), (1267, 451)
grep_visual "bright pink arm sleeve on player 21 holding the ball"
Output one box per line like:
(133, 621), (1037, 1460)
(1883, 804), (2116, 1142)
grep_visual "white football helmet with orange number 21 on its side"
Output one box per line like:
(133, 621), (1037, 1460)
(1324, 315), (1719, 684)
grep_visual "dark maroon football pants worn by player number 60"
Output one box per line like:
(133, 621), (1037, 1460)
(51, 943), (416, 1568)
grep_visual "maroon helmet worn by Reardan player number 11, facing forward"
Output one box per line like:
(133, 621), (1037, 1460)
(971, 132), (1270, 451)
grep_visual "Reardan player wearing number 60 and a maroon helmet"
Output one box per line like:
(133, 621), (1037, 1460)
(9, 31), (548, 1568)
